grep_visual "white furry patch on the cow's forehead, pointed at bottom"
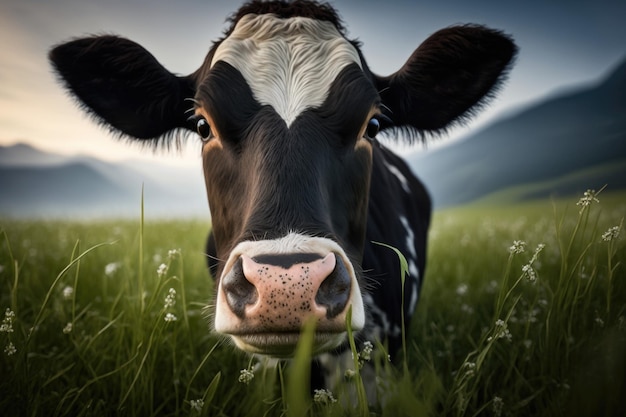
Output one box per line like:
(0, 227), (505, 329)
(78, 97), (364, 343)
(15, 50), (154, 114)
(211, 14), (361, 126)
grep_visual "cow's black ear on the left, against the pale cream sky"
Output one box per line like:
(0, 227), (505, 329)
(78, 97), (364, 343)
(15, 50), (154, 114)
(49, 36), (194, 139)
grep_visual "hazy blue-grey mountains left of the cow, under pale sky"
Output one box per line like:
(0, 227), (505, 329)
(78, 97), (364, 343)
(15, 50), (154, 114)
(0, 144), (209, 218)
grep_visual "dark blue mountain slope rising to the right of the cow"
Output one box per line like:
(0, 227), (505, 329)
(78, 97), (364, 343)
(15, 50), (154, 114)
(407, 57), (626, 207)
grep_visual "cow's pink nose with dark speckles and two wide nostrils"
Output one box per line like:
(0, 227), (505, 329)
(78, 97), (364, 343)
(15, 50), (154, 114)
(222, 253), (351, 331)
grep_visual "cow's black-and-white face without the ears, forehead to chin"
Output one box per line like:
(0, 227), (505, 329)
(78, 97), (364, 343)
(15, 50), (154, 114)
(195, 14), (380, 355)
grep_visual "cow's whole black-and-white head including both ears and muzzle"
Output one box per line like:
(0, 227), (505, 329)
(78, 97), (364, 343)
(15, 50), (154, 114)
(50, 1), (515, 356)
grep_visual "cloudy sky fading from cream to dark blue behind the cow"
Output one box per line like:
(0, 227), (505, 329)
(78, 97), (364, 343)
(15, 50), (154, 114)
(0, 0), (626, 164)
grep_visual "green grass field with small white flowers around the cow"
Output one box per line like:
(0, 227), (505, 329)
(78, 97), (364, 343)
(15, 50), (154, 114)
(0, 192), (626, 416)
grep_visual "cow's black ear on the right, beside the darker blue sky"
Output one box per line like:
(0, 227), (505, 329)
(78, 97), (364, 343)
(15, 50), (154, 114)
(376, 25), (517, 138)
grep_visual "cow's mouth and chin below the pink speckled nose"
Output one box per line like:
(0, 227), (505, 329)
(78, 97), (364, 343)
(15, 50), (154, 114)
(230, 332), (346, 358)
